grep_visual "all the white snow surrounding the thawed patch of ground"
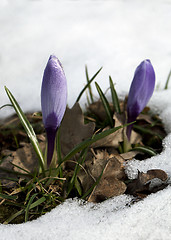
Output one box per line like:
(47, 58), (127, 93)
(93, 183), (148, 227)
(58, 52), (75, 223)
(0, 0), (171, 240)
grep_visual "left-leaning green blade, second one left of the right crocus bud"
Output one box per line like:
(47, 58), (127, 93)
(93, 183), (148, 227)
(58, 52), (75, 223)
(95, 82), (113, 127)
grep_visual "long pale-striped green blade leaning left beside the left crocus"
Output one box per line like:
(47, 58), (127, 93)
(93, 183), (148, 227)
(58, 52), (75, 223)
(5, 87), (44, 172)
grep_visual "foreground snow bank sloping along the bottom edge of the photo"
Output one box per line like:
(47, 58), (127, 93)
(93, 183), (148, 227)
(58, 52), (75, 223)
(1, 188), (171, 240)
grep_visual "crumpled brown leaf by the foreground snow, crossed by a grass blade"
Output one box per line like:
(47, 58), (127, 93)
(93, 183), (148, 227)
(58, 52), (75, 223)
(78, 150), (126, 202)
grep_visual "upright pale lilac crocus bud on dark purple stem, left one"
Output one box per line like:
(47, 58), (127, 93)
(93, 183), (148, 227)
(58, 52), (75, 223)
(41, 55), (67, 166)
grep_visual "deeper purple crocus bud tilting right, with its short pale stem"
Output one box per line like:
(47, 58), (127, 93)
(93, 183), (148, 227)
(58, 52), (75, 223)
(127, 60), (155, 139)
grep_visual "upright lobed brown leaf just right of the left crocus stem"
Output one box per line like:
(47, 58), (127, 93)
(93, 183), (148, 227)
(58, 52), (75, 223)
(60, 103), (95, 156)
